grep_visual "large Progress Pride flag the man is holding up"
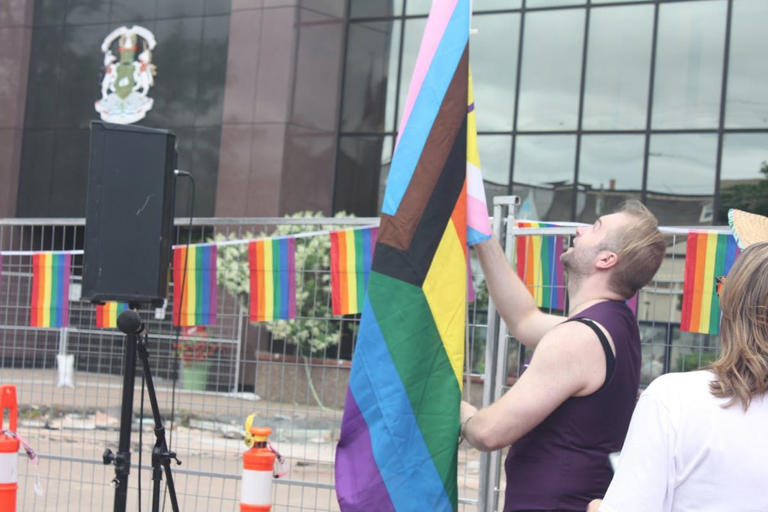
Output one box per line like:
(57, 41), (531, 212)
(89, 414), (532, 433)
(335, 0), (470, 512)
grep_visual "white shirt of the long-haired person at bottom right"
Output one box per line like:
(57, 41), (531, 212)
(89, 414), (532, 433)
(600, 370), (768, 512)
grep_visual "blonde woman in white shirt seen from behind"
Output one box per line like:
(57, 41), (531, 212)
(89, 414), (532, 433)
(587, 237), (768, 512)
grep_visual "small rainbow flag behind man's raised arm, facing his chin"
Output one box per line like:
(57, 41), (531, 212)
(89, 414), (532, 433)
(515, 221), (565, 310)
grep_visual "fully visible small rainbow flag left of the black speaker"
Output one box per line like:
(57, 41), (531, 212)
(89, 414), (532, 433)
(29, 252), (72, 327)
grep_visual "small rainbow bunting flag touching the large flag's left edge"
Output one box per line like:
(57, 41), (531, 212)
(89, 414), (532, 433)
(331, 228), (378, 315)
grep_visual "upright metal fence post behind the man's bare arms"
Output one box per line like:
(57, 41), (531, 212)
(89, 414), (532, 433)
(477, 196), (520, 512)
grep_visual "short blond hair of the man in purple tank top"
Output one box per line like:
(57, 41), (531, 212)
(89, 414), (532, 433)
(607, 199), (667, 298)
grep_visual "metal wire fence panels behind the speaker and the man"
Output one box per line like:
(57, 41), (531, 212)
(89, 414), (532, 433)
(0, 210), (718, 511)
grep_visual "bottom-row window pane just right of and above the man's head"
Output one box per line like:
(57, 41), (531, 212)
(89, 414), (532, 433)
(647, 134), (717, 226)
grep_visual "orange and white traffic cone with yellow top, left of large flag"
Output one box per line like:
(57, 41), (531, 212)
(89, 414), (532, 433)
(240, 427), (276, 512)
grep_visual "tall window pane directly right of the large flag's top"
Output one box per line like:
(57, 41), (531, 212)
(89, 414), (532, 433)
(469, 14), (520, 131)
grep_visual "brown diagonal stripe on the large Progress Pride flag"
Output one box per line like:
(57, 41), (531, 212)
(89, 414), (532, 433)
(377, 46), (469, 251)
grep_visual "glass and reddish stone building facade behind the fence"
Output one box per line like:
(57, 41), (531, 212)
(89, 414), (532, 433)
(0, 0), (768, 225)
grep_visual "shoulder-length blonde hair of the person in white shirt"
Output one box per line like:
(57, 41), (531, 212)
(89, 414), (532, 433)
(710, 242), (768, 410)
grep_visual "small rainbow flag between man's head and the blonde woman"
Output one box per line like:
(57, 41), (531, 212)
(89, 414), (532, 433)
(680, 231), (741, 334)
